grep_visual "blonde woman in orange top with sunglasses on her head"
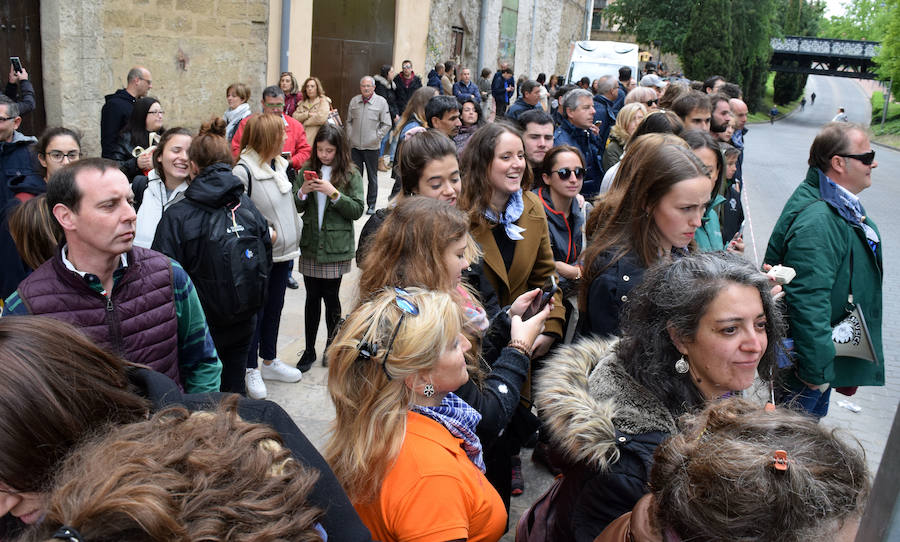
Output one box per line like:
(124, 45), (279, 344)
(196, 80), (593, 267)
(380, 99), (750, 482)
(325, 288), (507, 542)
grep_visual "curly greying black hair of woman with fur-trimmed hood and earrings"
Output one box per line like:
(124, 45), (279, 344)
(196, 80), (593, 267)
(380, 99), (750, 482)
(616, 252), (783, 415)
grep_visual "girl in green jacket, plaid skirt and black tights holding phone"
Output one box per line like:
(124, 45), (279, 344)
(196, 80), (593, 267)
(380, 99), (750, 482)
(295, 124), (365, 371)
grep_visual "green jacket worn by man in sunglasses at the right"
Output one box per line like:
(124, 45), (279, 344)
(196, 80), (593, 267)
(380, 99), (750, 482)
(765, 168), (884, 387)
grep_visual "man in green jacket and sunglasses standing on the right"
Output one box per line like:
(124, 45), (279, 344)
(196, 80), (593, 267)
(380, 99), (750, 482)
(765, 122), (884, 418)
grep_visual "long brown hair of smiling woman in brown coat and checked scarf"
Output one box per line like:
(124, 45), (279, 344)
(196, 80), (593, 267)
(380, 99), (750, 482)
(458, 121), (533, 225)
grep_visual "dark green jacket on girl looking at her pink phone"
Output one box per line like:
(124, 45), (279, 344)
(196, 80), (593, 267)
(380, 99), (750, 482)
(294, 167), (365, 263)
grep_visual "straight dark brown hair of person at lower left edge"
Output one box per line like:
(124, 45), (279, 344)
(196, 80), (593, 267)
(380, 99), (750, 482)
(0, 316), (149, 492)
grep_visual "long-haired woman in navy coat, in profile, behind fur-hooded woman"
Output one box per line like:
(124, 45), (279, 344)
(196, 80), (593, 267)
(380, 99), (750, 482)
(578, 134), (713, 337)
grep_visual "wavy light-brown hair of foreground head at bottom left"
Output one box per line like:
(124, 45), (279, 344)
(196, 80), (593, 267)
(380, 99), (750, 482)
(26, 395), (322, 542)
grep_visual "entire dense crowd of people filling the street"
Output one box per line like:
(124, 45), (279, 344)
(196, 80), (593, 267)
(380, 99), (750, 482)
(0, 56), (884, 542)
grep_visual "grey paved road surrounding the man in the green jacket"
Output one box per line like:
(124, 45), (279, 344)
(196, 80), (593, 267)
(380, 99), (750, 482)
(744, 76), (900, 472)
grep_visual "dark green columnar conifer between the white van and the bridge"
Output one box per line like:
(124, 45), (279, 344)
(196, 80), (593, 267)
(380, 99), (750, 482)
(681, 0), (738, 80)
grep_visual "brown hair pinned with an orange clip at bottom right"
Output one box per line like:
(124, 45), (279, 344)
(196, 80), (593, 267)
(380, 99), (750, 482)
(650, 398), (869, 542)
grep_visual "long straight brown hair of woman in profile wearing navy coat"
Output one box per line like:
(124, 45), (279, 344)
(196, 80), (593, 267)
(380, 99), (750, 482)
(579, 134), (706, 309)
